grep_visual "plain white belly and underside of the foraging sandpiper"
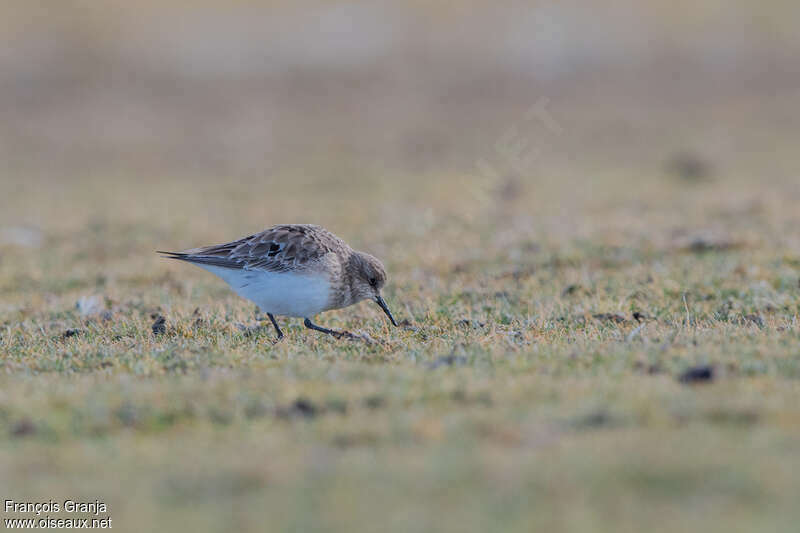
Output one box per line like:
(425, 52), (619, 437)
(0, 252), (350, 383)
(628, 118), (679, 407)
(197, 265), (330, 317)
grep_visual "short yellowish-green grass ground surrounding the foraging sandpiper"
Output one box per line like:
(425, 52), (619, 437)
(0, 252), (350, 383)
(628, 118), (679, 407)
(0, 140), (800, 532)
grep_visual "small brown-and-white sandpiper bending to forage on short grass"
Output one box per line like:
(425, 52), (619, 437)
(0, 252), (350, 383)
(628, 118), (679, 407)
(158, 224), (397, 339)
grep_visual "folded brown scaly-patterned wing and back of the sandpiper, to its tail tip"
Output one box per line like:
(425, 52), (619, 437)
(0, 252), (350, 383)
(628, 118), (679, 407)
(159, 224), (347, 272)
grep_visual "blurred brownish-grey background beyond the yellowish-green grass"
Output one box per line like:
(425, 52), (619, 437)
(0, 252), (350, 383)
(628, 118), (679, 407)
(0, 0), (800, 184)
